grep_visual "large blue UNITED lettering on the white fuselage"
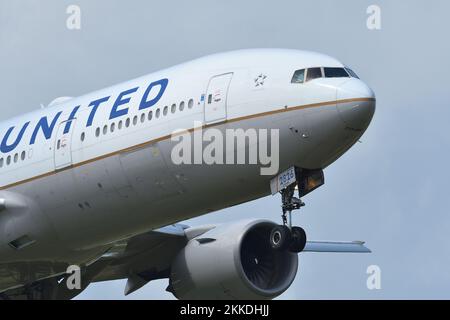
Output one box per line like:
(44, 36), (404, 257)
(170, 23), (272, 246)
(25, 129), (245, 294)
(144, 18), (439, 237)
(0, 78), (169, 153)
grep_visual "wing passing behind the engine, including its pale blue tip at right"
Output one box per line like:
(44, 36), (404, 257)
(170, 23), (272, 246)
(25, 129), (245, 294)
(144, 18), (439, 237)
(0, 224), (370, 300)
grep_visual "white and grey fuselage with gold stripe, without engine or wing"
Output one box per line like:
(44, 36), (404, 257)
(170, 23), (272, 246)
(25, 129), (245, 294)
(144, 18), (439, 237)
(0, 49), (375, 291)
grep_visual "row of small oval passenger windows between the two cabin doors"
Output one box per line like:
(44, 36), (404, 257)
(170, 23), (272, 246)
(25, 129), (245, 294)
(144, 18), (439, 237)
(80, 99), (194, 141)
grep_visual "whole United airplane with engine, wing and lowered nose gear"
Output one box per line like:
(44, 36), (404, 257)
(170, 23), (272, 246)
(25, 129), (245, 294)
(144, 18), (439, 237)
(0, 49), (376, 299)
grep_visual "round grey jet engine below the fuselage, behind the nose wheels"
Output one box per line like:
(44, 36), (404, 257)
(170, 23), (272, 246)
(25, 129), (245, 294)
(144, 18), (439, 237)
(170, 220), (298, 300)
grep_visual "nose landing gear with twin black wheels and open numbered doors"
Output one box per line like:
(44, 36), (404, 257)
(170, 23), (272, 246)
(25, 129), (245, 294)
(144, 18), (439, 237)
(270, 167), (324, 253)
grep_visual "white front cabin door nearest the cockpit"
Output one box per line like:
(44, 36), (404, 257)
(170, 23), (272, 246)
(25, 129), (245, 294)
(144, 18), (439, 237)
(204, 73), (233, 124)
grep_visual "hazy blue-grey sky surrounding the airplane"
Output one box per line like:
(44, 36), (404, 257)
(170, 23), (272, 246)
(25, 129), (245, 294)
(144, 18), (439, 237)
(0, 0), (450, 299)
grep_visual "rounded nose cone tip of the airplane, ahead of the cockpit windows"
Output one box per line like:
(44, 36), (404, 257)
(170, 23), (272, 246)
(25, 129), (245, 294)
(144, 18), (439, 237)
(336, 78), (376, 130)
